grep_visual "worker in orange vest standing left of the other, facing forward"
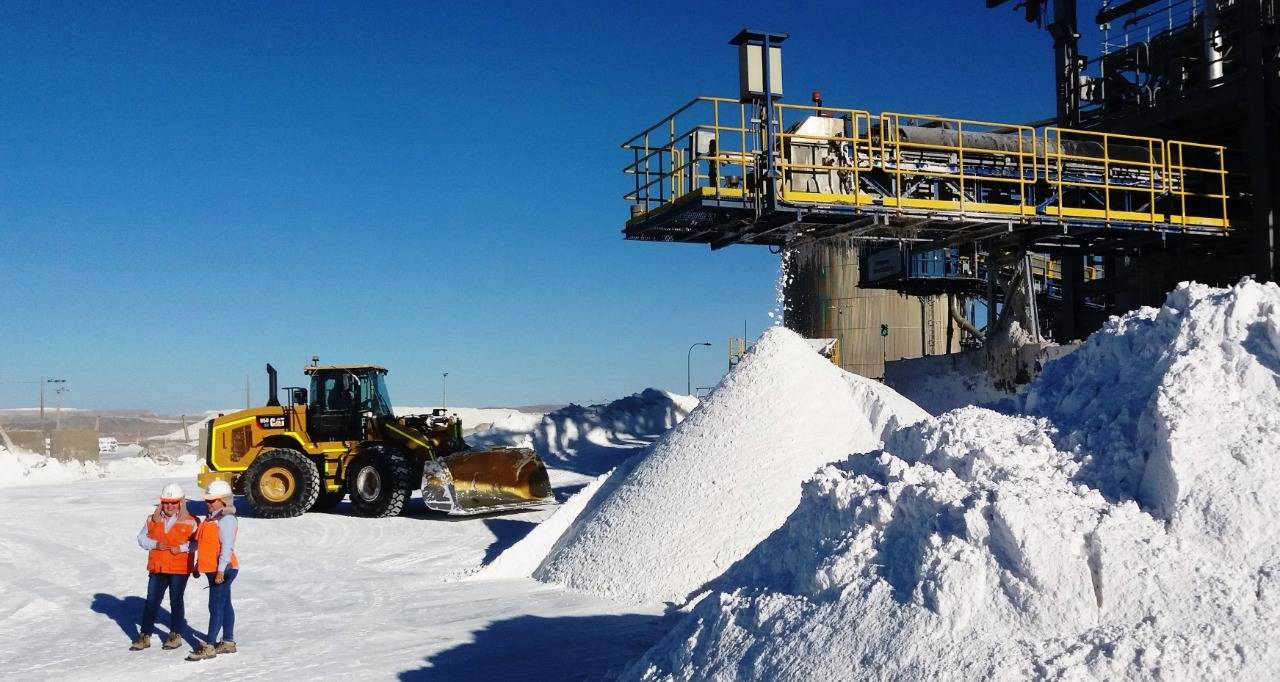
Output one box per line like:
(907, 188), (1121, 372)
(129, 484), (196, 651)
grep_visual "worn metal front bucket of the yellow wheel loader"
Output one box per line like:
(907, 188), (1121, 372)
(422, 448), (556, 516)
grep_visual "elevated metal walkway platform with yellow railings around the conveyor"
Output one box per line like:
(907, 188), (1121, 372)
(623, 97), (1231, 250)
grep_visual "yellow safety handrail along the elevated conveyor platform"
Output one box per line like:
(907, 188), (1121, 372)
(622, 97), (1229, 230)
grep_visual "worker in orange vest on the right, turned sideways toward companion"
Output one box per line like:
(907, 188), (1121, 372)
(187, 481), (239, 660)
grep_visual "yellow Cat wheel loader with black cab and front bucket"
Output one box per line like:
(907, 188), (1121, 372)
(197, 362), (554, 518)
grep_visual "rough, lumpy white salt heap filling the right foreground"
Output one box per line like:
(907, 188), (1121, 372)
(627, 282), (1280, 679)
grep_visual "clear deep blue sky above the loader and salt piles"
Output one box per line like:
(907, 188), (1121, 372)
(0, 0), (1059, 411)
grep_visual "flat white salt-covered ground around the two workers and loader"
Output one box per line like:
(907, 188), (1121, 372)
(0, 392), (696, 679)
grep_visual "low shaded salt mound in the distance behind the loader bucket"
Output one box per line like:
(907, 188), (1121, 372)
(467, 388), (698, 476)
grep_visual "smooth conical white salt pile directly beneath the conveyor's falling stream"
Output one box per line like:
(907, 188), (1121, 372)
(524, 328), (928, 603)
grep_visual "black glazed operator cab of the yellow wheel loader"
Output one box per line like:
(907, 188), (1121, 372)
(306, 365), (392, 443)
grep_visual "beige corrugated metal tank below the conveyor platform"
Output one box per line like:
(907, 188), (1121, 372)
(783, 239), (960, 379)
